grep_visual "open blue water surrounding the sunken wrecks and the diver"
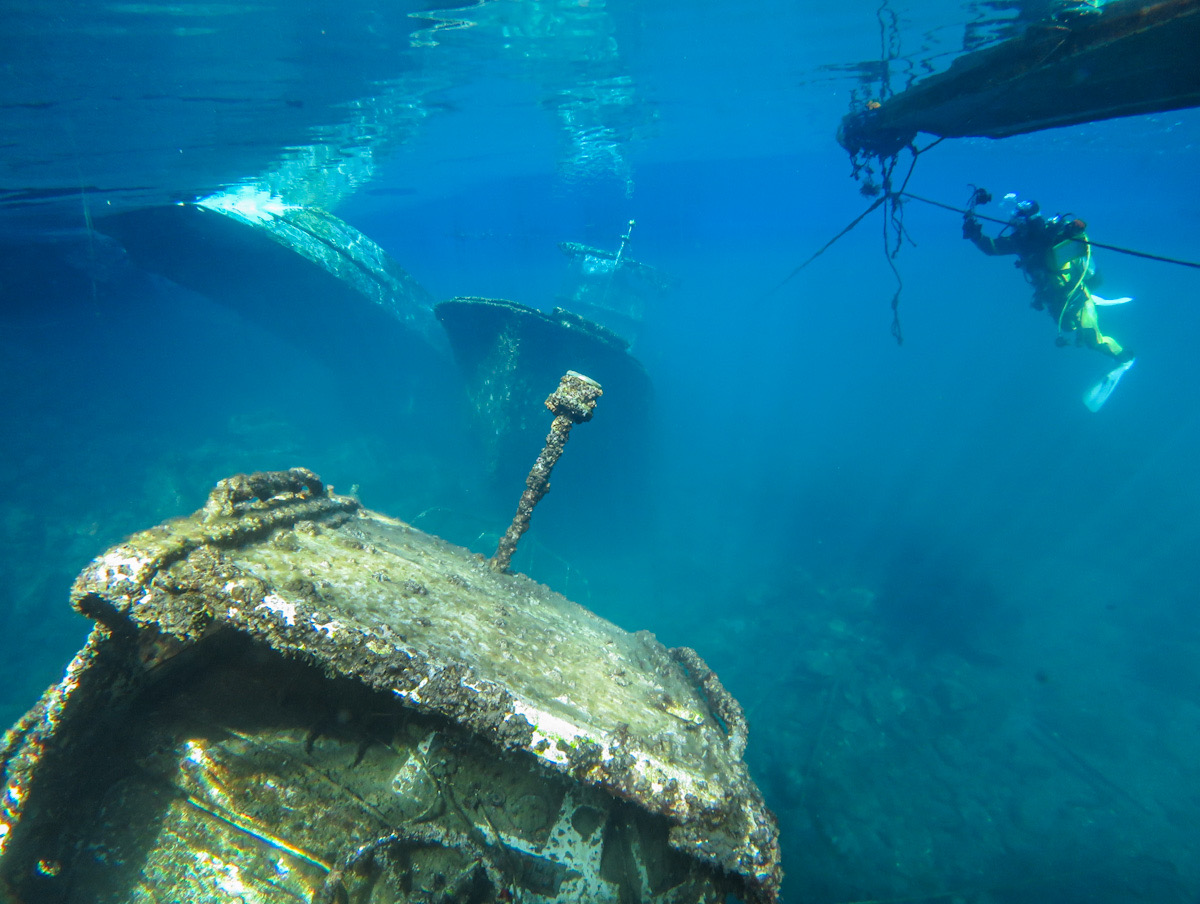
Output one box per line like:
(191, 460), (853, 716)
(0, 0), (1200, 904)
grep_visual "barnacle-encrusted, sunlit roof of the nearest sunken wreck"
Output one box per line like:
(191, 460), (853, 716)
(0, 469), (780, 900)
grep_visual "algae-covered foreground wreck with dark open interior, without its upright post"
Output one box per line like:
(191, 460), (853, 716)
(0, 468), (780, 904)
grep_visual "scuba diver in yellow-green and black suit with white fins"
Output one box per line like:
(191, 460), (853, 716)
(962, 195), (1134, 412)
